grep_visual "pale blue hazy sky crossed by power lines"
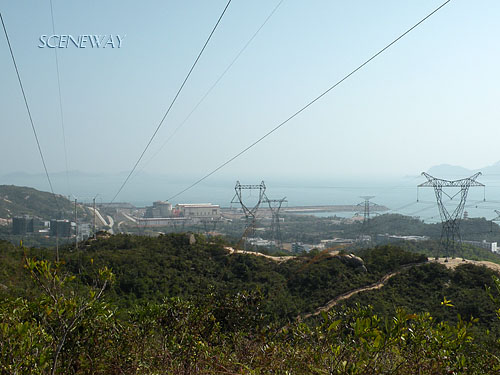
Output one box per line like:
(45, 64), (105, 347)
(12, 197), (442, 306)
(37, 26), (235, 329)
(0, 0), (500, 203)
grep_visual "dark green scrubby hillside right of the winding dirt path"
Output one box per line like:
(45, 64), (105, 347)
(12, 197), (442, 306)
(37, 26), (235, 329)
(343, 263), (500, 340)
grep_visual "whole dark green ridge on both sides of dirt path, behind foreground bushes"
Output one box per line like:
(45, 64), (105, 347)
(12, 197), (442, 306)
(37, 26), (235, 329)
(0, 234), (500, 332)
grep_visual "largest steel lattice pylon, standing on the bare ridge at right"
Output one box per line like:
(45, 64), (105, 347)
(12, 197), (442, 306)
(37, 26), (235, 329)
(417, 172), (485, 258)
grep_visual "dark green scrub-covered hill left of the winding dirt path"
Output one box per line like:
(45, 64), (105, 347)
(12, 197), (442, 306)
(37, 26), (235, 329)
(0, 234), (427, 319)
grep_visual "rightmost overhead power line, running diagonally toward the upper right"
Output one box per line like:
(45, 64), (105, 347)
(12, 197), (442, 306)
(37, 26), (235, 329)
(168, 0), (451, 200)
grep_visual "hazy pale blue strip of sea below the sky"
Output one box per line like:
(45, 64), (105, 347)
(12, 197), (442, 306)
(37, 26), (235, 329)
(0, 172), (500, 222)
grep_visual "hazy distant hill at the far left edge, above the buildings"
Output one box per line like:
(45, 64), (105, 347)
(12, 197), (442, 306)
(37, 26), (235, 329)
(0, 185), (84, 220)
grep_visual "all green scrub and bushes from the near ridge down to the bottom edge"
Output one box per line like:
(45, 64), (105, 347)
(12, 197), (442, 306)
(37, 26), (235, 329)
(0, 234), (500, 374)
